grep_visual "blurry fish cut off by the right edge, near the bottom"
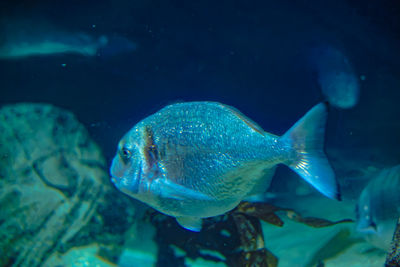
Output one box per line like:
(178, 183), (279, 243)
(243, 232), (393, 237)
(356, 165), (400, 250)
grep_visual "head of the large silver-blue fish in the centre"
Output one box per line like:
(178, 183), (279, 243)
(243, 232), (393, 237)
(110, 128), (143, 197)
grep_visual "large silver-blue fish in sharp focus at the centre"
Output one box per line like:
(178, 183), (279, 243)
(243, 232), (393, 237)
(110, 102), (340, 231)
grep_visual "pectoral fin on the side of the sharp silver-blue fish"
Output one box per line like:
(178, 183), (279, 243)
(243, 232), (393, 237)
(158, 180), (212, 201)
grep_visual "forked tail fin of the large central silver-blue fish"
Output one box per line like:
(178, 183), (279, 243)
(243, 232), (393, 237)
(281, 103), (340, 200)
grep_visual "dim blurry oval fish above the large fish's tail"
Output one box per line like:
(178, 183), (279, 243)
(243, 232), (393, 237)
(309, 46), (360, 109)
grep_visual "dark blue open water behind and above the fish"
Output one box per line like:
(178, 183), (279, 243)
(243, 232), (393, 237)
(0, 0), (400, 266)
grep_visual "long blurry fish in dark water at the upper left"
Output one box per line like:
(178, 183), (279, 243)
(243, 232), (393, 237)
(0, 20), (137, 59)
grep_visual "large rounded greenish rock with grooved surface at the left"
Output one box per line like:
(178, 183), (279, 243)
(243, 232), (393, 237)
(0, 103), (108, 267)
